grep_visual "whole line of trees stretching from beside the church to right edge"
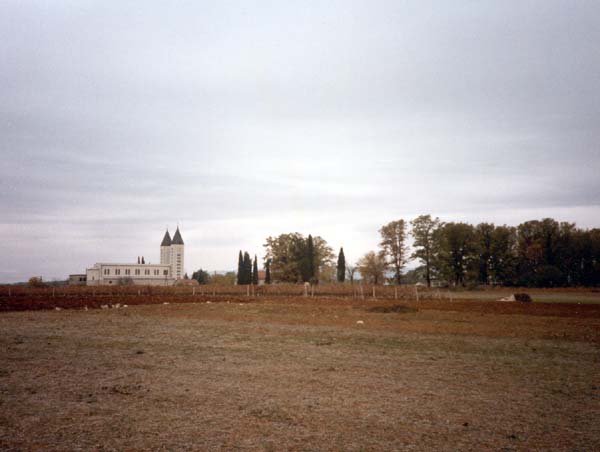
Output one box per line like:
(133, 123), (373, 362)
(192, 215), (600, 287)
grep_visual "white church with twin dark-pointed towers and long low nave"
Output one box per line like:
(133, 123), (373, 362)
(85, 227), (184, 286)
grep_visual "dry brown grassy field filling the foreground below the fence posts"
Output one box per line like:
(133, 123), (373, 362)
(0, 297), (600, 451)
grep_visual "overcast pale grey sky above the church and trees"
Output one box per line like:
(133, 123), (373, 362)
(0, 0), (600, 282)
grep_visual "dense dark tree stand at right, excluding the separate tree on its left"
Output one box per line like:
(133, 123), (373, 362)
(411, 215), (600, 287)
